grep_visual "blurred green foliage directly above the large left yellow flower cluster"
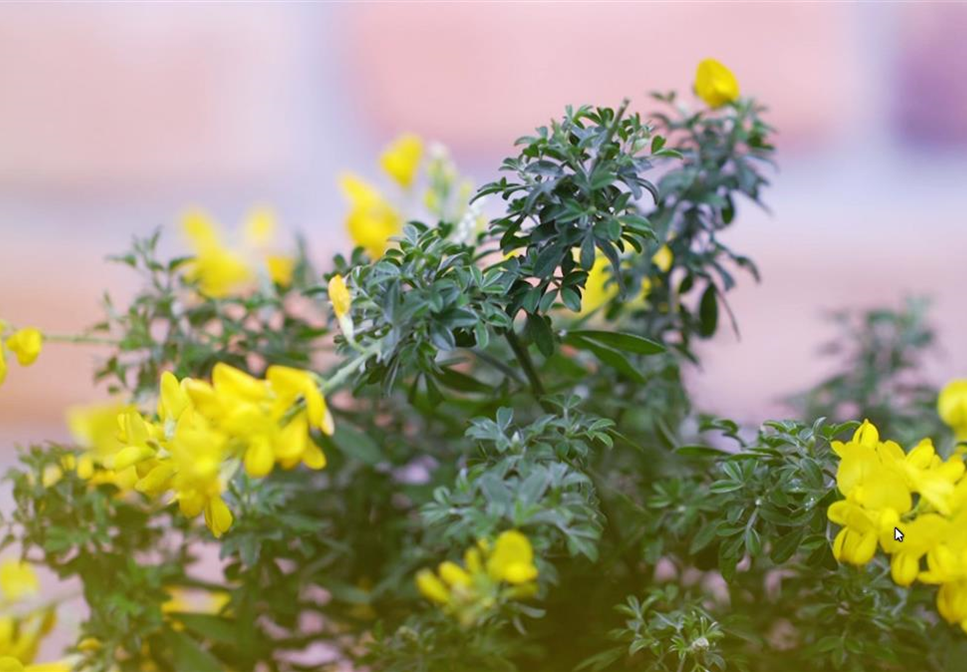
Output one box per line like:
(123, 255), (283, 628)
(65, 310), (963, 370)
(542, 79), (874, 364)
(97, 230), (329, 400)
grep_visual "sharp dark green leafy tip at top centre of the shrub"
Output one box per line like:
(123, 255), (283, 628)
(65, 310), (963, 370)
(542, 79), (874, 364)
(477, 101), (679, 326)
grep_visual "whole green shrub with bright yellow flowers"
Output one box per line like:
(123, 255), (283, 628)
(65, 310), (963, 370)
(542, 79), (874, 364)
(0, 60), (967, 672)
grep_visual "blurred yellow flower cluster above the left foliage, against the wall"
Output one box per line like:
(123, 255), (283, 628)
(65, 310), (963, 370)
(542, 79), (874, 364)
(181, 208), (295, 298)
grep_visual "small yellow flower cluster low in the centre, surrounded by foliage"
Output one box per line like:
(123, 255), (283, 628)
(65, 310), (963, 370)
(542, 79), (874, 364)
(416, 530), (537, 626)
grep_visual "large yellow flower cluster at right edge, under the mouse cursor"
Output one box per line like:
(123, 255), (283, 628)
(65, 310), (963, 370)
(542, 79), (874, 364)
(827, 421), (967, 631)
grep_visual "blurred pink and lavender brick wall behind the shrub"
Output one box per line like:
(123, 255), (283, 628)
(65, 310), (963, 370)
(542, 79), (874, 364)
(0, 2), (967, 452)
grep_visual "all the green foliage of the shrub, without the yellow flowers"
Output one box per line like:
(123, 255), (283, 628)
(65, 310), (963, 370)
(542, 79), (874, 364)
(3, 89), (965, 672)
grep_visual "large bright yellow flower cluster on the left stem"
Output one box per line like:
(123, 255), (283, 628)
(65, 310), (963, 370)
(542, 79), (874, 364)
(66, 364), (333, 537)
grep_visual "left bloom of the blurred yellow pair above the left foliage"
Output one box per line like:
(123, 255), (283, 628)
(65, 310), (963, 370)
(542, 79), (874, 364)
(182, 210), (253, 298)
